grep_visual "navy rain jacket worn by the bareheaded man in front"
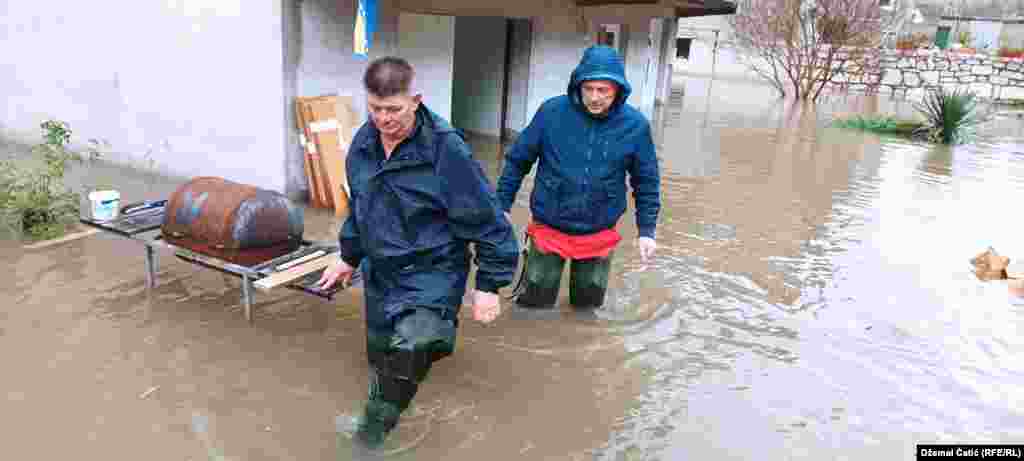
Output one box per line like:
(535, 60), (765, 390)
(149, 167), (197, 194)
(339, 104), (519, 330)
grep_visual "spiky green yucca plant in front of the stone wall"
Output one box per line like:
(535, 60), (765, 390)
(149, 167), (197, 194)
(913, 87), (988, 144)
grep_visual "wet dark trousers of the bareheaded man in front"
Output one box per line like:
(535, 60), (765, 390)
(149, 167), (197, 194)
(356, 307), (458, 447)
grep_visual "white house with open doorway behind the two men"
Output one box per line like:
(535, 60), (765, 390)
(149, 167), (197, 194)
(0, 0), (735, 201)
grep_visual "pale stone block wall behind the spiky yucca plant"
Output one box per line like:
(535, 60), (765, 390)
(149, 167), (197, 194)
(860, 50), (1024, 99)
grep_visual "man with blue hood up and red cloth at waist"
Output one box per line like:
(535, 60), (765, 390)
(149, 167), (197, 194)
(498, 46), (660, 308)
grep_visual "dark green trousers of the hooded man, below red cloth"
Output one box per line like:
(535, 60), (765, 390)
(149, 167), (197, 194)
(516, 241), (614, 308)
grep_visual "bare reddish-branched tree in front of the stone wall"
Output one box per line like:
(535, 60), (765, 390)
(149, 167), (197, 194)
(730, 0), (905, 101)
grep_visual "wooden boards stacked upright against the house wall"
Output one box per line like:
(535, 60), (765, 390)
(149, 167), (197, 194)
(295, 94), (358, 217)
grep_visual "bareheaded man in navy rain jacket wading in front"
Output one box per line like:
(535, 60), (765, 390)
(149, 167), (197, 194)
(321, 57), (519, 446)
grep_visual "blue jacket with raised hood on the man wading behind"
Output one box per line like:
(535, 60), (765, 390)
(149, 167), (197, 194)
(498, 46), (660, 238)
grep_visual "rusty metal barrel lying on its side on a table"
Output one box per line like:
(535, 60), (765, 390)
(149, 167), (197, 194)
(161, 176), (304, 265)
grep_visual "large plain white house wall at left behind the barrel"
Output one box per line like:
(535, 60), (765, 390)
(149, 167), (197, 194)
(0, 0), (286, 191)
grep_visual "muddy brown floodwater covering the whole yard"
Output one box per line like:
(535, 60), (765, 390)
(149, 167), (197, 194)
(0, 76), (1024, 460)
